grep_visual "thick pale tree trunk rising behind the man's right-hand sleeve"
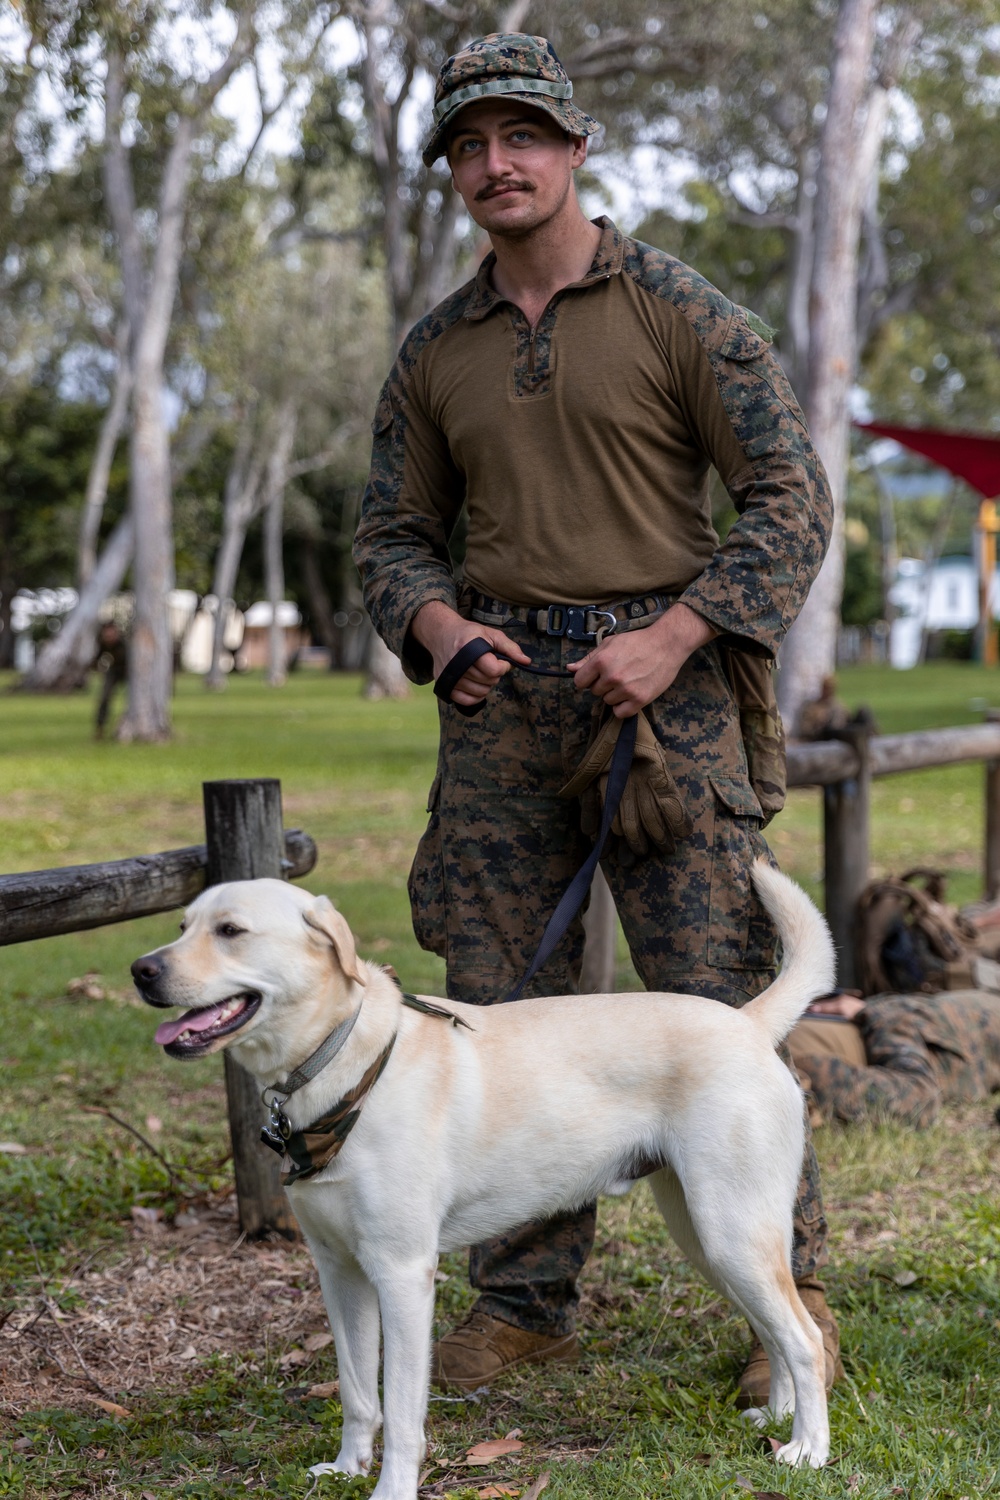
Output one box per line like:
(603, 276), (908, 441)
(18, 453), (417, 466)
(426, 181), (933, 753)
(778, 0), (877, 729)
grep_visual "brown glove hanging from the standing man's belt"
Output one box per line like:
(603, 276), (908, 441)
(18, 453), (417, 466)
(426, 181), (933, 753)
(559, 714), (694, 858)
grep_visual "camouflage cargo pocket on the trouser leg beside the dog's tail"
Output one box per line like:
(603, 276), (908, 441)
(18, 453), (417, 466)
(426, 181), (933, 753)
(708, 776), (775, 969)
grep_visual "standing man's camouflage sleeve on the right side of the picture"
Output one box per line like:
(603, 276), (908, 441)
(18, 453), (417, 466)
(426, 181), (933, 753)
(682, 305), (834, 656)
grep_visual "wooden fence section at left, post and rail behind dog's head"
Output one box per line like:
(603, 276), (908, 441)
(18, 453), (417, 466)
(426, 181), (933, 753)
(0, 779), (316, 1236)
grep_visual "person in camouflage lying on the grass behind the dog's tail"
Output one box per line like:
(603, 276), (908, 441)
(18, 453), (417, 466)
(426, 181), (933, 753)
(789, 990), (1000, 1127)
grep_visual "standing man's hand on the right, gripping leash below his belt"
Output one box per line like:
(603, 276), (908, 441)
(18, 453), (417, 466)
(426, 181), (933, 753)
(568, 603), (718, 719)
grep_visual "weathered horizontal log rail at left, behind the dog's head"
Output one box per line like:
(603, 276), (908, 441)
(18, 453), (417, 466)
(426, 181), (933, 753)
(0, 828), (316, 947)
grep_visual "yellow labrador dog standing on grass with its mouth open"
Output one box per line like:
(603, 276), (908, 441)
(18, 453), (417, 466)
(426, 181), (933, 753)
(132, 863), (834, 1500)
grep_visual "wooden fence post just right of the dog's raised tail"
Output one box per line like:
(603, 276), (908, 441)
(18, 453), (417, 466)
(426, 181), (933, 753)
(823, 708), (874, 990)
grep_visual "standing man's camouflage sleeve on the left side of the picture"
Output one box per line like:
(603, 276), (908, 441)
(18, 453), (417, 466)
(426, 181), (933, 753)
(354, 328), (465, 683)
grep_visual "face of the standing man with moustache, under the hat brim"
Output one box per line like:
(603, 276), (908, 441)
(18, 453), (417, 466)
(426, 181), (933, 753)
(448, 99), (586, 239)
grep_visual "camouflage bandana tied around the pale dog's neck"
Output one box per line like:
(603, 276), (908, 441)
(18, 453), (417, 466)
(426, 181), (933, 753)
(261, 981), (472, 1187)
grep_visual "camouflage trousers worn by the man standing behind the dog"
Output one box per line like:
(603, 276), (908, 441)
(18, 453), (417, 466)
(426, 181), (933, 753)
(409, 620), (826, 1335)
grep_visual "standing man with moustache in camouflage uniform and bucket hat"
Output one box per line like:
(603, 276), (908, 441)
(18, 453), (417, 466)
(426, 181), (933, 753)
(355, 35), (838, 1404)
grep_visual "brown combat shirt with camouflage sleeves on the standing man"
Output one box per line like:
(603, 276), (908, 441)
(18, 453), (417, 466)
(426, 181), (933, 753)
(355, 219), (831, 681)
